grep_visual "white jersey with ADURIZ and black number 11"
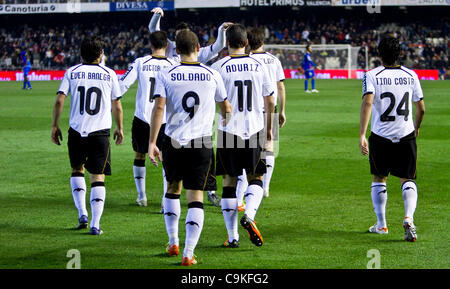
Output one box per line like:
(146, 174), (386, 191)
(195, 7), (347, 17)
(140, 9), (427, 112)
(211, 54), (274, 139)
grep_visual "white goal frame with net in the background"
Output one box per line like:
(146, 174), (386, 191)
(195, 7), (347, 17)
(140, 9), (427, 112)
(264, 44), (368, 78)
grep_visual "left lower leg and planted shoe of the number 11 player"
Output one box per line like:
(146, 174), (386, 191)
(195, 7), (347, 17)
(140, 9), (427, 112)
(221, 175), (239, 248)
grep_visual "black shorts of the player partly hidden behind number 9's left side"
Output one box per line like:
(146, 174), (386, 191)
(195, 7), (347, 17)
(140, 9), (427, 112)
(131, 116), (166, 154)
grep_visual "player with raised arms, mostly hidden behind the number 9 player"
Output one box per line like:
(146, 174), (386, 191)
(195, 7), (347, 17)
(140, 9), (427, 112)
(148, 7), (233, 207)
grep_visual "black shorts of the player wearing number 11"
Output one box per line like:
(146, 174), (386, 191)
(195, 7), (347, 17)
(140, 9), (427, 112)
(216, 130), (266, 177)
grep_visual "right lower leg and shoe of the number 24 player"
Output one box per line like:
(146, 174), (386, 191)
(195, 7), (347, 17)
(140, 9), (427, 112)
(400, 178), (417, 242)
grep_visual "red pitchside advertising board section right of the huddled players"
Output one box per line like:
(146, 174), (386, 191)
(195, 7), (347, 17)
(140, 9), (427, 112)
(284, 69), (439, 80)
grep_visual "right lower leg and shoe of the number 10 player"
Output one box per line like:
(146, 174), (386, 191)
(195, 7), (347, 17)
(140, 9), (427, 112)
(90, 174), (106, 235)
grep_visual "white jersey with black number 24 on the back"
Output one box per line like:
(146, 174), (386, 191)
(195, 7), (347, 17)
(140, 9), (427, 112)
(363, 66), (423, 142)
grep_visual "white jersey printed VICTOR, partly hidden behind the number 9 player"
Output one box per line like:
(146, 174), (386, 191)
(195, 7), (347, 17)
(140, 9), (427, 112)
(119, 55), (176, 124)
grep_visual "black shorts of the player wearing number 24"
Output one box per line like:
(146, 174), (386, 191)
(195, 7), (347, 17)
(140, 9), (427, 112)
(369, 132), (417, 179)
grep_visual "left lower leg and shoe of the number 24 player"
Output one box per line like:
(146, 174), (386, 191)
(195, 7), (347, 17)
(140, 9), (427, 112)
(369, 175), (388, 234)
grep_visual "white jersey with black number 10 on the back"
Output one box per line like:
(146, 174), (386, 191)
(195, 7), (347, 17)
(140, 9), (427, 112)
(58, 64), (122, 137)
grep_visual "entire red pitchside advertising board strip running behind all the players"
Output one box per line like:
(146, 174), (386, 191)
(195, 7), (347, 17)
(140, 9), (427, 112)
(0, 69), (439, 81)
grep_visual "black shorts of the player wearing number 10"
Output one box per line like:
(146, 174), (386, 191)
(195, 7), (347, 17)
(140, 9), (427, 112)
(67, 128), (111, 175)
